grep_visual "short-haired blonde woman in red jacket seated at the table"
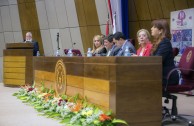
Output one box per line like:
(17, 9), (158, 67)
(132, 29), (152, 56)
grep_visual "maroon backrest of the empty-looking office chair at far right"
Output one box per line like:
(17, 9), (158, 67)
(178, 47), (194, 85)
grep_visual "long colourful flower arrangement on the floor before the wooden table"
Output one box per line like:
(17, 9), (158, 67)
(13, 84), (128, 126)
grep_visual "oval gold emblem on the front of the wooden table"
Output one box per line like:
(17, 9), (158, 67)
(55, 60), (67, 95)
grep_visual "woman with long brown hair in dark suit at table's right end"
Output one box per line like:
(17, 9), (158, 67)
(151, 19), (179, 85)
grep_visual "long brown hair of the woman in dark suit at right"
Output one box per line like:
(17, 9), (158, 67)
(151, 19), (171, 55)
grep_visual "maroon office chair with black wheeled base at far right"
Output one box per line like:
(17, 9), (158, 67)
(162, 47), (194, 126)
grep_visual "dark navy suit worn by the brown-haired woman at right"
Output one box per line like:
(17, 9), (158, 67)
(153, 38), (179, 85)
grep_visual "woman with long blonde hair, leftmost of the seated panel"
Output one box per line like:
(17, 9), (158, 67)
(92, 35), (107, 56)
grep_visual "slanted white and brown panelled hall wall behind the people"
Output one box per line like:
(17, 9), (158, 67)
(0, 0), (194, 82)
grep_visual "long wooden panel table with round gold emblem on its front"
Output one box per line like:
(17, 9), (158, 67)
(34, 57), (162, 126)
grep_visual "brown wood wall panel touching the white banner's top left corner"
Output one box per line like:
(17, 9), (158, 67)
(160, 0), (175, 18)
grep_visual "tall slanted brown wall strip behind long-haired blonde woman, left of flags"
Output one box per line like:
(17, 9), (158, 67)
(74, 0), (101, 52)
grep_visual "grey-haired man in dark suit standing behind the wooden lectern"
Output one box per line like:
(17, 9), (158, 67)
(24, 32), (39, 56)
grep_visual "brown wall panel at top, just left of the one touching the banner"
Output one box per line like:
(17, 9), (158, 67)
(148, 0), (163, 19)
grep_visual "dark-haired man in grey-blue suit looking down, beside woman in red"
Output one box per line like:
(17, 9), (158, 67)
(113, 32), (136, 56)
